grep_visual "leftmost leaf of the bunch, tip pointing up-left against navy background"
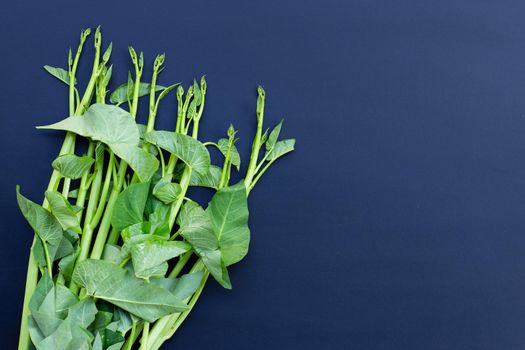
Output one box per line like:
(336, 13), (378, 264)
(16, 186), (63, 256)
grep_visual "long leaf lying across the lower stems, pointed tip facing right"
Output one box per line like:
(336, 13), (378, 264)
(73, 259), (188, 322)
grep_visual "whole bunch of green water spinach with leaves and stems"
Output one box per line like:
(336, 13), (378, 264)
(17, 28), (295, 350)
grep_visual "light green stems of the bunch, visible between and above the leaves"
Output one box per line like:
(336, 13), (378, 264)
(19, 28), (271, 350)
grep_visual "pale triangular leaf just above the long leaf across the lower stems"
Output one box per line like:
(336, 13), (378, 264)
(123, 235), (191, 279)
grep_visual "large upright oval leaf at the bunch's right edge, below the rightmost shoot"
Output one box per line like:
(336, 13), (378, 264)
(207, 181), (250, 266)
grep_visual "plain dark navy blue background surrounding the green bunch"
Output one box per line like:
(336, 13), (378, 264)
(0, 0), (525, 350)
